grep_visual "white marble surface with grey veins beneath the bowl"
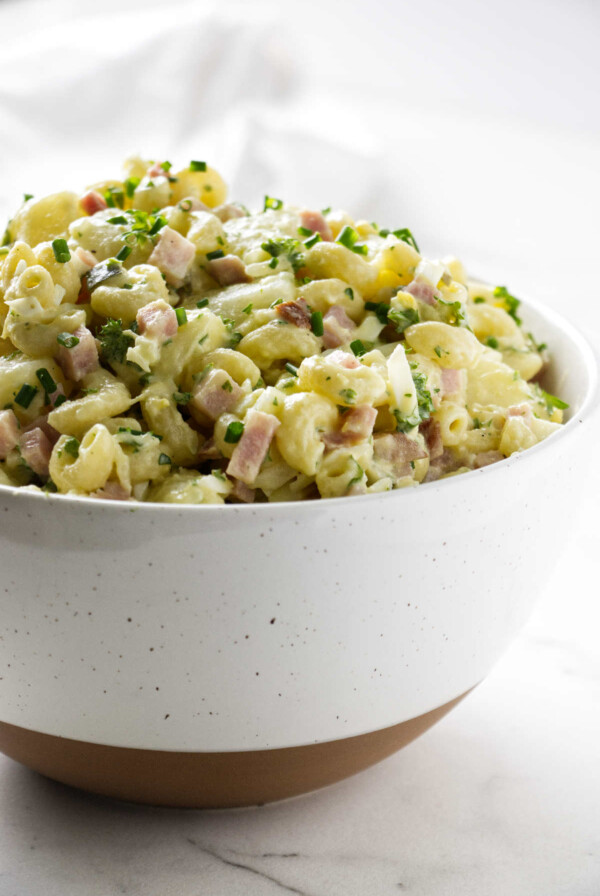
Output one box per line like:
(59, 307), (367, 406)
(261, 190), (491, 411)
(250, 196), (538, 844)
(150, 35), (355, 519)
(0, 479), (600, 896)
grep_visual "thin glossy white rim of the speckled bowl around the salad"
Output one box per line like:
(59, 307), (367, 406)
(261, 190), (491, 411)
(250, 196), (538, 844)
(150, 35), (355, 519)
(0, 298), (600, 516)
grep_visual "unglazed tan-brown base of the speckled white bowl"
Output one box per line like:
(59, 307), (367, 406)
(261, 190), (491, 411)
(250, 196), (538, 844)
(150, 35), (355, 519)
(0, 694), (466, 809)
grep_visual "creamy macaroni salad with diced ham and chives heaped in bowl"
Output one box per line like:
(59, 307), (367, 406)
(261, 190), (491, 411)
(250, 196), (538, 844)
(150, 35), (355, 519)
(0, 158), (567, 504)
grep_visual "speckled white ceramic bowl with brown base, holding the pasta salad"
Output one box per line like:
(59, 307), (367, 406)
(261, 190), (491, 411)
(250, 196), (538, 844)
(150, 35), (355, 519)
(0, 296), (599, 806)
